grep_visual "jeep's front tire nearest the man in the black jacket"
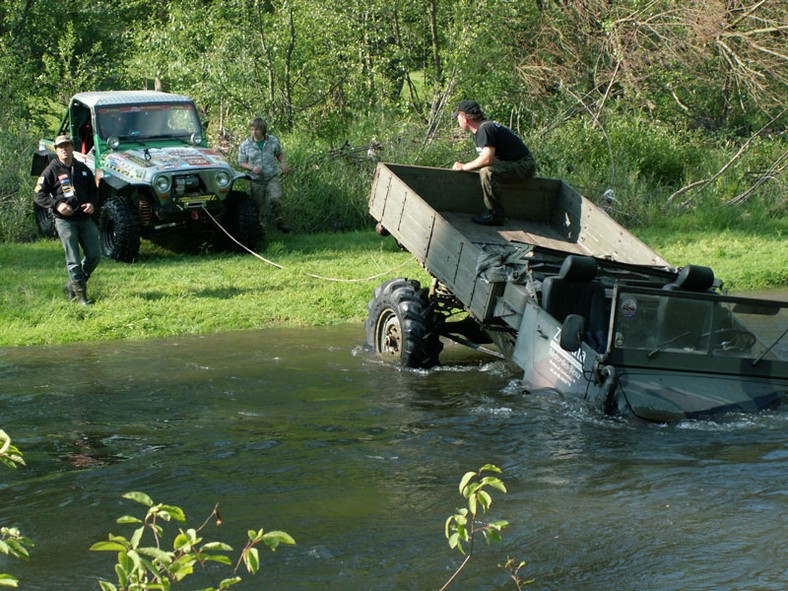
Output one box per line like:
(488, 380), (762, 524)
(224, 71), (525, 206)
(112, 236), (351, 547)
(99, 194), (140, 263)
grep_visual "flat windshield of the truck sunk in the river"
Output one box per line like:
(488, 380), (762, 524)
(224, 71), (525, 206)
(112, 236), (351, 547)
(609, 287), (788, 378)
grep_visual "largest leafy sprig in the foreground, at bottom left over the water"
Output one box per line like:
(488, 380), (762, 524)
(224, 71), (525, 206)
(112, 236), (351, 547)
(90, 492), (295, 591)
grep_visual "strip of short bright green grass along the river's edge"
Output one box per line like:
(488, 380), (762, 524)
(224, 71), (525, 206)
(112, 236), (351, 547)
(0, 228), (788, 346)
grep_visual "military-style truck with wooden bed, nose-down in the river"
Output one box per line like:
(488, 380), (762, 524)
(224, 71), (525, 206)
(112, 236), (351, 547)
(365, 163), (788, 422)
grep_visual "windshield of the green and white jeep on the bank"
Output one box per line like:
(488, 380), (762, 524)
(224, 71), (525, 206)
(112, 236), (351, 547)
(96, 103), (202, 141)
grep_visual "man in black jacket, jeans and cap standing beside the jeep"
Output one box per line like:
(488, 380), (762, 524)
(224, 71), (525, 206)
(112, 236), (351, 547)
(33, 135), (101, 306)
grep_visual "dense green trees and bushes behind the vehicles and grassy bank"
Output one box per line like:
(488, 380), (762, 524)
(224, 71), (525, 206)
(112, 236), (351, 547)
(0, 0), (788, 241)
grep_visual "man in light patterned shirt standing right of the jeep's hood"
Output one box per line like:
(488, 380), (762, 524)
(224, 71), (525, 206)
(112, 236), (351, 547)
(238, 117), (290, 234)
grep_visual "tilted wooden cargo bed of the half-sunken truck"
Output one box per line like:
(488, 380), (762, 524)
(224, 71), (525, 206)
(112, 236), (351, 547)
(369, 163), (669, 320)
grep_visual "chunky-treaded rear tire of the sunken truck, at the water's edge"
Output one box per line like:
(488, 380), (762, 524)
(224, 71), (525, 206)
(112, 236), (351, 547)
(364, 278), (443, 369)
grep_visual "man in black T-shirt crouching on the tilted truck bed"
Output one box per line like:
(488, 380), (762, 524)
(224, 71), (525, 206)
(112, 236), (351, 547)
(452, 101), (536, 226)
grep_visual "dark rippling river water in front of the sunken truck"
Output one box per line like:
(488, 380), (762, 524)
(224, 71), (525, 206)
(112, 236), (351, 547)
(0, 326), (788, 591)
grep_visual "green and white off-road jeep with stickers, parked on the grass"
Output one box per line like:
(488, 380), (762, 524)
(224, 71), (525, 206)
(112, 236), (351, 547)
(31, 91), (264, 262)
